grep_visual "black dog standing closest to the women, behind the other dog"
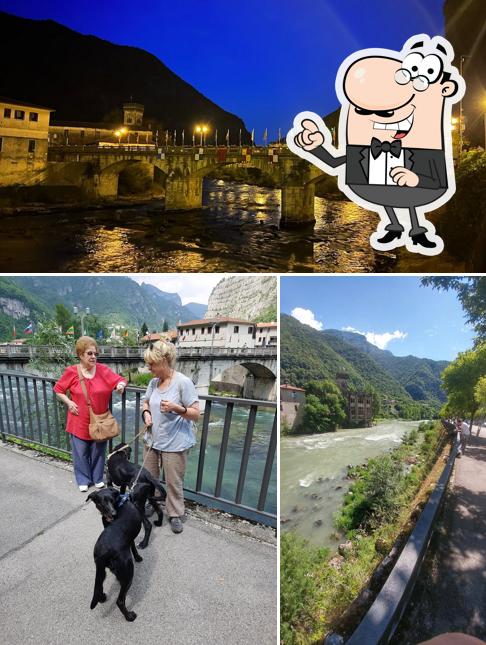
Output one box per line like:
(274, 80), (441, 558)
(106, 443), (167, 526)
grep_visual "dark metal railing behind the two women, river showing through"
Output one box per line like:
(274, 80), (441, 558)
(0, 371), (277, 527)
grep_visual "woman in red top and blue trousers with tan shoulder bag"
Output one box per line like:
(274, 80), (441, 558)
(54, 336), (127, 493)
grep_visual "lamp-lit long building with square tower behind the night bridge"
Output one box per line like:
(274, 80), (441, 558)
(49, 103), (154, 147)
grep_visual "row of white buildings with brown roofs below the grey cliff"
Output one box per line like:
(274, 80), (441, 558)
(177, 318), (277, 349)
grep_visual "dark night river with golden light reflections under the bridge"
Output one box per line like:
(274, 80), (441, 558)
(0, 180), (394, 273)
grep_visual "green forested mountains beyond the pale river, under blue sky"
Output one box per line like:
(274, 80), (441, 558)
(280, 314), (448, 410)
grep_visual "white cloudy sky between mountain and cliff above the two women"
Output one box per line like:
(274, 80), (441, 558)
(128, 273), (223, 305)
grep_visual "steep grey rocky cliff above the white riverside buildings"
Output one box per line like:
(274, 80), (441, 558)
(204, 276), (277, 322)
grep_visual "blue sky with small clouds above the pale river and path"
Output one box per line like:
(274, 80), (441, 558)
(280, 276), (474, 360)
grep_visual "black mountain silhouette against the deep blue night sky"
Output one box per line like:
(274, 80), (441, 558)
(0, 12), (251, 143)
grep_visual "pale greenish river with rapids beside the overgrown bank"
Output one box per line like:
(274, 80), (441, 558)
(280, 421), (419, 547)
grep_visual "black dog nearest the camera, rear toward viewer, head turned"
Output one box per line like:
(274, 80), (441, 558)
(86, 488), (143, 622)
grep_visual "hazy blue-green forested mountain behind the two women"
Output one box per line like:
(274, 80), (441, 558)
(0, 275), (206, 341)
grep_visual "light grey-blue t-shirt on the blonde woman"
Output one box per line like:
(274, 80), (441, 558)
(144, 372), (198, 452)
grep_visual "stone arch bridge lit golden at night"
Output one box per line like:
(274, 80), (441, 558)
(43, 145), (326, 226)
